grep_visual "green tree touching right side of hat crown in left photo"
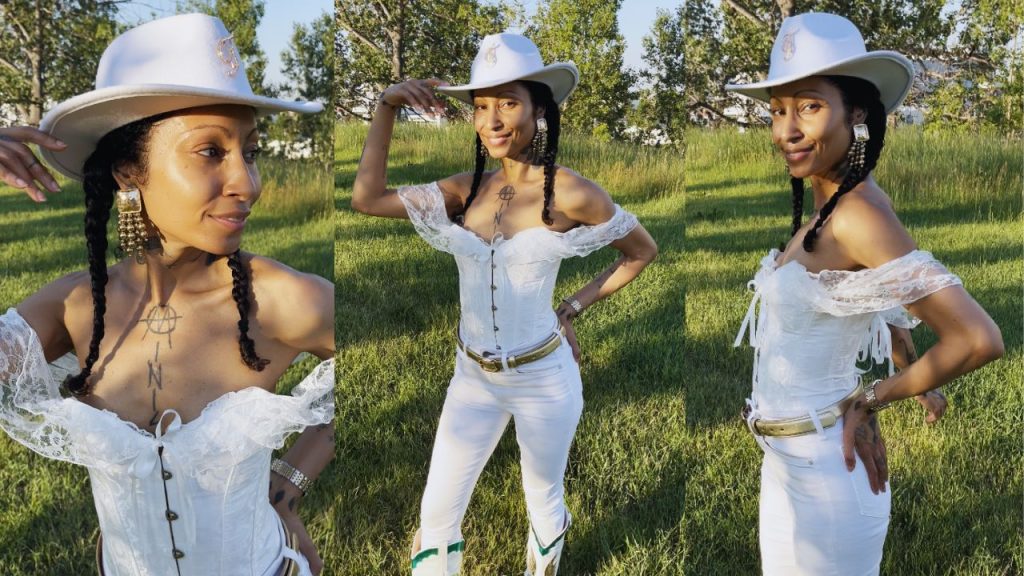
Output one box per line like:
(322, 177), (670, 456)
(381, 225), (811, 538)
(178, 0), (273, 94)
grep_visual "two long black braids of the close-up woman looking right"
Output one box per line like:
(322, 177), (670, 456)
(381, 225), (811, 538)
(63, 114), (268, 397)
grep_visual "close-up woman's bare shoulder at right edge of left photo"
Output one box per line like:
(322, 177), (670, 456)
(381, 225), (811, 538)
(243, 254), (334, 343)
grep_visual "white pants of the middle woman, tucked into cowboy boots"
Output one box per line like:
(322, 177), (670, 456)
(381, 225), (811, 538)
(420, 337), (583, 548)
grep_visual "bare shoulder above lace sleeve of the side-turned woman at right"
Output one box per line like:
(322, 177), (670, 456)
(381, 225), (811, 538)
(830, 180), (916, 268)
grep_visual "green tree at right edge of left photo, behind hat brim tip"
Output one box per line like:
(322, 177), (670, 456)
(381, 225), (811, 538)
(270, 12), (335, 164)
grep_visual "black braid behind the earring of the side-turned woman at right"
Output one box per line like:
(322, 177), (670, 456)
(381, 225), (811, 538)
(804, 76), (886, 252)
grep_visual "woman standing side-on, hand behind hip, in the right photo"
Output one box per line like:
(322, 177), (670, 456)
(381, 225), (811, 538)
(727, 13), (1002, 575)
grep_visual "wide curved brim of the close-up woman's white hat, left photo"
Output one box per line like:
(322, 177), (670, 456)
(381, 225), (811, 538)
(39, 84), (324, 180)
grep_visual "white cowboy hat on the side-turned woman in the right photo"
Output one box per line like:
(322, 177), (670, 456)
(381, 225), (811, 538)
(725, 12), (913, 114)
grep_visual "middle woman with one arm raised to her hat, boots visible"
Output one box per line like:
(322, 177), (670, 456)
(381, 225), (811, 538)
(352, 34), (656, 576)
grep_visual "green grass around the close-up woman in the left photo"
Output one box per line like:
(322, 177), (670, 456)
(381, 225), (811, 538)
(0, 151), (331, 576)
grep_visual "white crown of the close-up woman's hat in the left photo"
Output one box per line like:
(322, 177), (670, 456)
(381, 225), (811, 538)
(96, 14), (253, 96)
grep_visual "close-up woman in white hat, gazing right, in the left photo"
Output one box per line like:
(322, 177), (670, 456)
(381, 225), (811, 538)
(0, 14), (334, 576)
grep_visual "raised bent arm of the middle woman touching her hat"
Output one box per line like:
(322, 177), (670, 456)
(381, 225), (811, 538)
(352, 78), (446, 218)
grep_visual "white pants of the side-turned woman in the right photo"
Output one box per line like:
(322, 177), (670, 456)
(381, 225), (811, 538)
(755, 418), (890, 576)
